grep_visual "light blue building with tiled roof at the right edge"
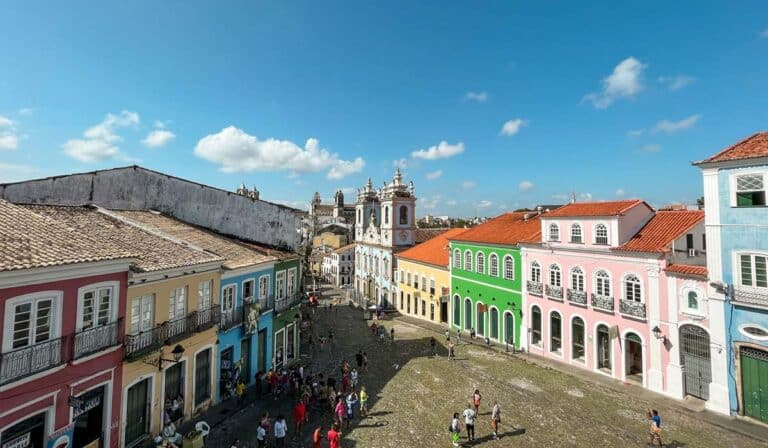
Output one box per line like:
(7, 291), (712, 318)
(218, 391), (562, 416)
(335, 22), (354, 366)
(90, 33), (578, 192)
(695, 132), (768, 423)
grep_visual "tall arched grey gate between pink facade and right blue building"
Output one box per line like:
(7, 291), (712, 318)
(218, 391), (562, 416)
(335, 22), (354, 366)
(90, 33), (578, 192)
(680, 325), (712, 400)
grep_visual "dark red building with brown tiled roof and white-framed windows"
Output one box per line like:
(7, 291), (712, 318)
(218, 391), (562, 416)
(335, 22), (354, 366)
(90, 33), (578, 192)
(0, 200), (132, 448)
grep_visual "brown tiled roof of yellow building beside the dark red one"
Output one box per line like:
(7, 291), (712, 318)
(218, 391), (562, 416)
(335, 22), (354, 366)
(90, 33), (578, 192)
(23, 205), (222, 272)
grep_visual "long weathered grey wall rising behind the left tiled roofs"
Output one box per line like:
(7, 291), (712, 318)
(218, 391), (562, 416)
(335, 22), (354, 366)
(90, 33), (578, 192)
(0, 166), (299, 250)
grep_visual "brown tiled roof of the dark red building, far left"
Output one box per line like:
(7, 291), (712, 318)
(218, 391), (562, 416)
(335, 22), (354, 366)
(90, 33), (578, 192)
(0, 199), (136, 271)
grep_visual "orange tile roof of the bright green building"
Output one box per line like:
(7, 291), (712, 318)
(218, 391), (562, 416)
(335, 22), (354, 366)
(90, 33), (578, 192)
(444, 212), (541, 245)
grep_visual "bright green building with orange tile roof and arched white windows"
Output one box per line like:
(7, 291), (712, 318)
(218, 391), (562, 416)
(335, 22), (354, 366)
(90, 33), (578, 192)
(450, 212), (541, 348)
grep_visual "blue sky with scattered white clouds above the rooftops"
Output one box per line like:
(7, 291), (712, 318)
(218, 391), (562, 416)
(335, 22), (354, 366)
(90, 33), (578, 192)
(0, 0), (768, 216)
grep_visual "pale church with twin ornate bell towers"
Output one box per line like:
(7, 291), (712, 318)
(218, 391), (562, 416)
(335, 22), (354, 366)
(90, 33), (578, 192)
(355, 168), (416, 308)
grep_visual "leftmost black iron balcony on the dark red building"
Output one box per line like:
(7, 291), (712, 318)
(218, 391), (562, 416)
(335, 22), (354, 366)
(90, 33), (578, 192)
(0, 338), (66, 385)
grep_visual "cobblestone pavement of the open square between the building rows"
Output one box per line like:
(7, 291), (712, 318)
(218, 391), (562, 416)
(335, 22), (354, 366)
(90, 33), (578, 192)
(206, 288), (768, 448)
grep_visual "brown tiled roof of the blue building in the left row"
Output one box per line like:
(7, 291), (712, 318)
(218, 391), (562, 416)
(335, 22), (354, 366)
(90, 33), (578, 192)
(112, 211), (276, 269)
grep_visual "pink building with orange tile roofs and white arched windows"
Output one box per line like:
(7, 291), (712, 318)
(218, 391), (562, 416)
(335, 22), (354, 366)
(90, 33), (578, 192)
(521, 200), (720, 398)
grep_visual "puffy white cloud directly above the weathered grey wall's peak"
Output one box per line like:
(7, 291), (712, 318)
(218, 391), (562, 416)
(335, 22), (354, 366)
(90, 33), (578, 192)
(63, 110), (140, 162)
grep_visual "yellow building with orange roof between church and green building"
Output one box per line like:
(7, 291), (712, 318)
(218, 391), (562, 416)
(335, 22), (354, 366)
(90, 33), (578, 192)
(395, 229), (466, 324)
